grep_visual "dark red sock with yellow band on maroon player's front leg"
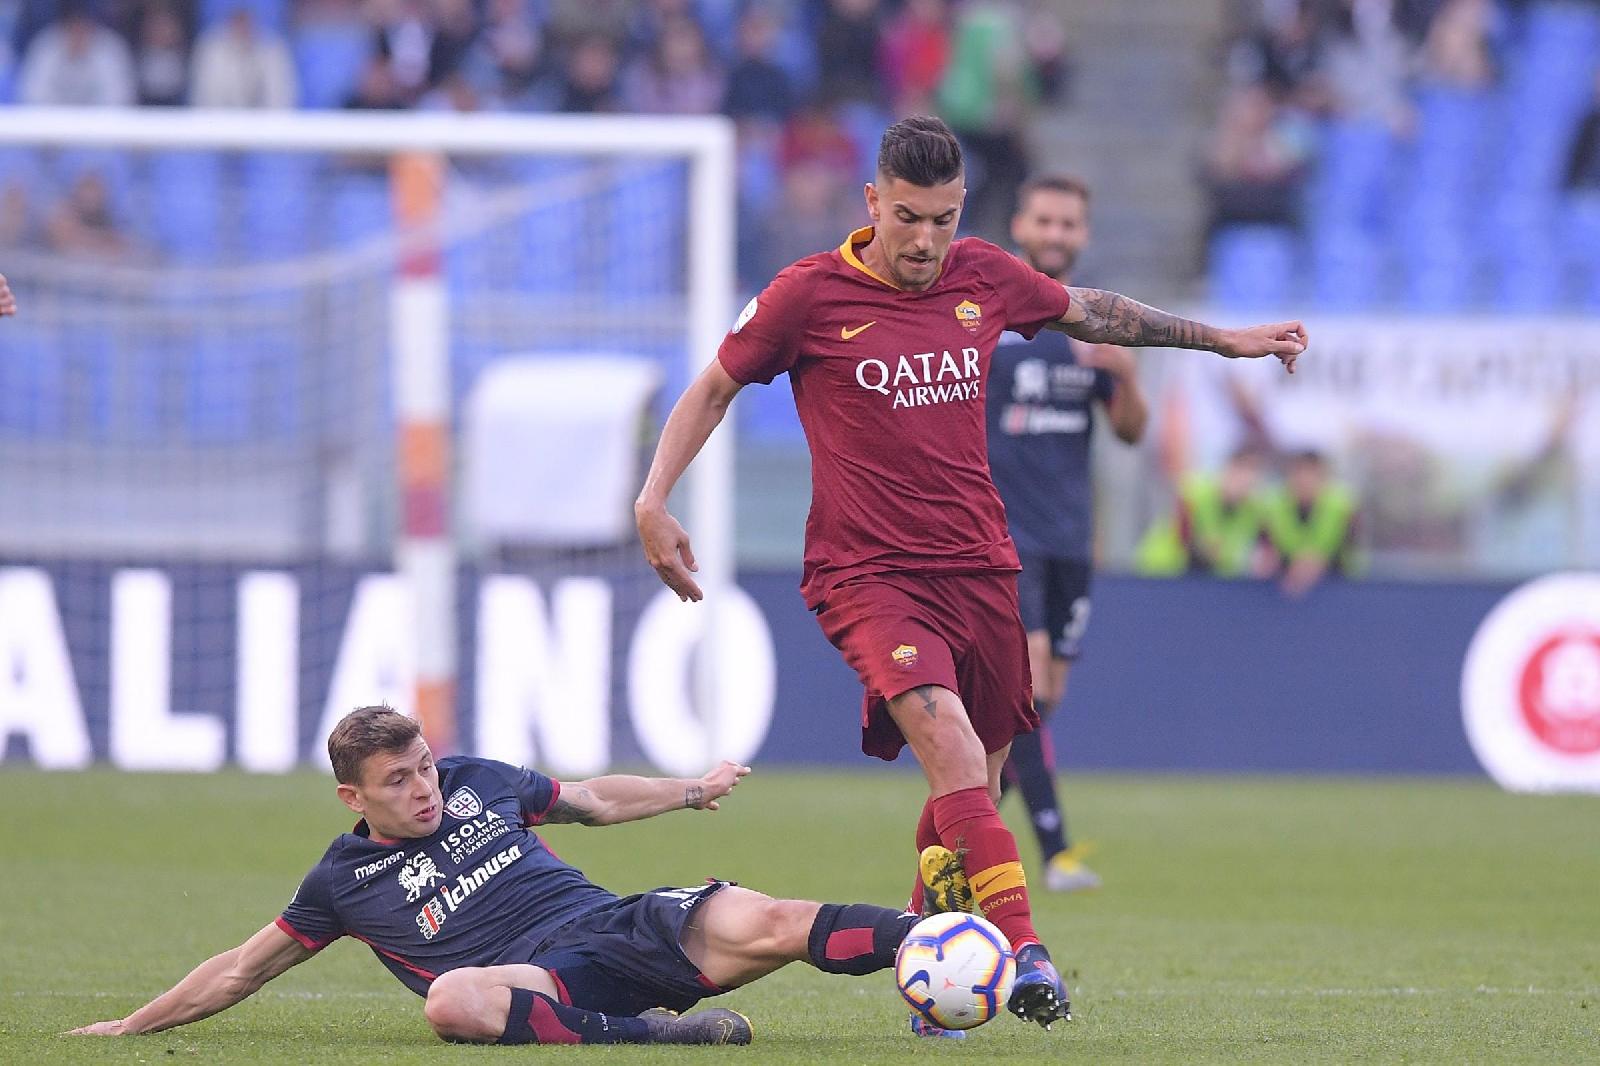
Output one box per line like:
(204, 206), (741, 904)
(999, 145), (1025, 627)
(933, 787), (1038, 951)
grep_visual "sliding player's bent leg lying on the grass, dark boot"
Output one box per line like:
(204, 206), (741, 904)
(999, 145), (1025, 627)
(422, 964), (750, 1044)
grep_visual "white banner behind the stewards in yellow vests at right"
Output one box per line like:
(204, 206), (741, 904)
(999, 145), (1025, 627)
(1152, 317), (1600, 575)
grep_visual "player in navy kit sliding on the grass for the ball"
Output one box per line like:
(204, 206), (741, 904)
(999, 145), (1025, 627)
(74, 707), (917, 1044)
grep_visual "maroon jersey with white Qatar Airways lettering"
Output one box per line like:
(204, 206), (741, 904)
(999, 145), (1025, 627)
(717, 227), (1069, 608)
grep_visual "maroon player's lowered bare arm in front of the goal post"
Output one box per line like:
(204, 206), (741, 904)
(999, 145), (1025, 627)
(634, 359), (744, 600)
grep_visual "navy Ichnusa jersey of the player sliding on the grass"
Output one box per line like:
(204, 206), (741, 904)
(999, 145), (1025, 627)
(277, 757), (616, 996)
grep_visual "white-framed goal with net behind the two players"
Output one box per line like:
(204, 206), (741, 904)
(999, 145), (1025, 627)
(0, 109), (771, 773)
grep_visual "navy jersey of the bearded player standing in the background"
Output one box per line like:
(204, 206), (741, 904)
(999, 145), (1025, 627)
(987, 330), (1114, 562)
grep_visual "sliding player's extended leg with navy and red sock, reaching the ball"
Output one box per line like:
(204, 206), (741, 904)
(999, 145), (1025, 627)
(678, 885), (915, 989)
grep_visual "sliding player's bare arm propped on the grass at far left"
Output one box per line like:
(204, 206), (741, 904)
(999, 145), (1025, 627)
(70, 925), (317, 1036)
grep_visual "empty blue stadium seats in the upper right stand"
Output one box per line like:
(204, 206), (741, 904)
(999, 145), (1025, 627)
(1208, 0), (1600, 312)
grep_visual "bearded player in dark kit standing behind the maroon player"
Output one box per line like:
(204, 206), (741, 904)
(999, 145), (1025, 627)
(987, 176), (1149, 892)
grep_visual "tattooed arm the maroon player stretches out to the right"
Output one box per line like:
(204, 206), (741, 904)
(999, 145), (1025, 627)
(1045, 287), (1309, 373)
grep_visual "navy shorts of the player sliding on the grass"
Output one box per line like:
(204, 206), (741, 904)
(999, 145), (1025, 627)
(494, 880), (733, 1016)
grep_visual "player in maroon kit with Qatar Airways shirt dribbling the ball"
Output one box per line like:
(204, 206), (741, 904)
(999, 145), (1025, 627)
(634, 117), (1306, 1028)
